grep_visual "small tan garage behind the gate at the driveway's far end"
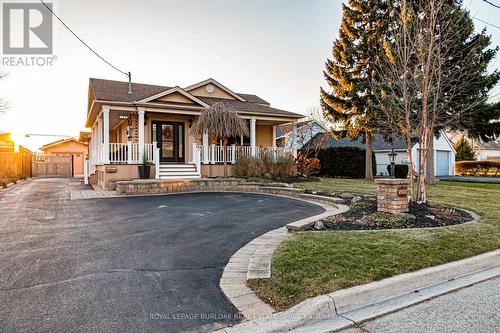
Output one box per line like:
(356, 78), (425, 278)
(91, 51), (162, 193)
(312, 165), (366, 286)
(40, 138), (88, 177)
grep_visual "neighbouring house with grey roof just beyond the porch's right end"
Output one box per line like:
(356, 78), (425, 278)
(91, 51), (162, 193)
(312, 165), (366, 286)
(276, 120), (327, 149)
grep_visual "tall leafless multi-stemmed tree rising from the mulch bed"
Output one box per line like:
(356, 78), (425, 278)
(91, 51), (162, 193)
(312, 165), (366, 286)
(377, 0), (484, 202)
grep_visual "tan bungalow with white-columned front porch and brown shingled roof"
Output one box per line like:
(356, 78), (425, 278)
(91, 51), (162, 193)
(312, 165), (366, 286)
(85, 78), (303, 187)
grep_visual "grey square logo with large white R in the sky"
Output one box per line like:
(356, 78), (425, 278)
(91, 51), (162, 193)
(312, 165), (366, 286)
(2, 2), (53, 54)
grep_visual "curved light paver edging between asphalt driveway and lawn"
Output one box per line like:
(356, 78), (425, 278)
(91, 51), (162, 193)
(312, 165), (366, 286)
(219, 192), (349, 319)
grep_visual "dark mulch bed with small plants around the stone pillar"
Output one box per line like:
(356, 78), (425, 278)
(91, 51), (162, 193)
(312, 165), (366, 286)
(309, 193), (472, 231)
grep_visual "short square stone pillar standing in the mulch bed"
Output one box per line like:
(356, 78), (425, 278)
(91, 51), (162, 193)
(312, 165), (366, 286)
(375, 178), (408, 214)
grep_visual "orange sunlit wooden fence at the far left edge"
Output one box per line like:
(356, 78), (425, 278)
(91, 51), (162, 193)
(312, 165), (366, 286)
(0, 146), (32, 183)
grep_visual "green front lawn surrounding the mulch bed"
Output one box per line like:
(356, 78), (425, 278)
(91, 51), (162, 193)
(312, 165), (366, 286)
(248, 179), (500, 310)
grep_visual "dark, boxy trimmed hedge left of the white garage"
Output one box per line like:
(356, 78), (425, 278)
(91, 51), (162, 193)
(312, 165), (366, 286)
(316, 147), (377, 178)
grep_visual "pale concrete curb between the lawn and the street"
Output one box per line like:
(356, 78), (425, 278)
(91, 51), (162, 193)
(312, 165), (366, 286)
(218, 250), (500, 333)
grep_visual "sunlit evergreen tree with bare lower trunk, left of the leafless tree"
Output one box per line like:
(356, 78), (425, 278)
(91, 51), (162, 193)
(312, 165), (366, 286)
(320, 0), (392, 180)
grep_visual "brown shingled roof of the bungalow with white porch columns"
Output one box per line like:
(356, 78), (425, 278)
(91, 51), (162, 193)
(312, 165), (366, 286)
(86, 78), (304, 126)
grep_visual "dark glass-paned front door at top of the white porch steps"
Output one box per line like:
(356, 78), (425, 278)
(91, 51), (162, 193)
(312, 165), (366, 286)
(151, 121), (184, 163)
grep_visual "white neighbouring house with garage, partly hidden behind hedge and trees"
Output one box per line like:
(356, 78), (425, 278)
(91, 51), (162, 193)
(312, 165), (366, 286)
(306, 132), (456, 176)
